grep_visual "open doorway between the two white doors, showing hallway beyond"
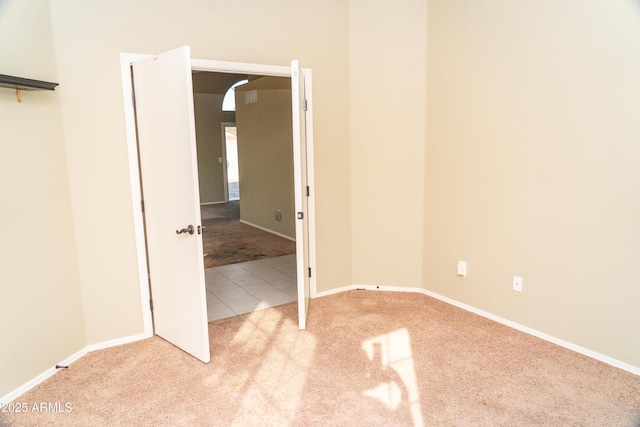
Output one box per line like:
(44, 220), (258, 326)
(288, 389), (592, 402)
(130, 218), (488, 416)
(193, 72), (298, 321)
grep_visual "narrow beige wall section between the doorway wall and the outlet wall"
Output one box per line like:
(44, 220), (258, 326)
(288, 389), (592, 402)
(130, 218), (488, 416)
(348, 0), (426, 287)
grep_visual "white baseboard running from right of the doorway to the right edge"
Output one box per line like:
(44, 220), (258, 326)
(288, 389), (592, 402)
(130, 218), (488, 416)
(317, 285), (640, 376)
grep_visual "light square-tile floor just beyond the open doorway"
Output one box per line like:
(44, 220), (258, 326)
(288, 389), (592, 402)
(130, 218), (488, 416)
(205, 254), (298, 321)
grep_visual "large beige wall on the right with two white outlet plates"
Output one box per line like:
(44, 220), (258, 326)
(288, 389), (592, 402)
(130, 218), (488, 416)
(424, 0), (640, 367)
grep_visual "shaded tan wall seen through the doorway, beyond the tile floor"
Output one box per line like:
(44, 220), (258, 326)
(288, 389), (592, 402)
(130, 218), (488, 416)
(236, 77), (296, 238)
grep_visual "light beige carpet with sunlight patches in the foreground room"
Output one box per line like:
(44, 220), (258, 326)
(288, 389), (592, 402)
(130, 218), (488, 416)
(0, 291), (640, 426)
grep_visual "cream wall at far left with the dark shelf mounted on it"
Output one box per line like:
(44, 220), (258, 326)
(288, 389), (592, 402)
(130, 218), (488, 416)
(0, 0), (86, 397)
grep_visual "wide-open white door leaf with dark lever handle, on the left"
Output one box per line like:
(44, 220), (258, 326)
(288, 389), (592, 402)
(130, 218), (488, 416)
(133, 47), (210, 363)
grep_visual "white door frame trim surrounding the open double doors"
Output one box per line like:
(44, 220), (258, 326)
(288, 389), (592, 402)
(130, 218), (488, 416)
(120, 52), (318, 337)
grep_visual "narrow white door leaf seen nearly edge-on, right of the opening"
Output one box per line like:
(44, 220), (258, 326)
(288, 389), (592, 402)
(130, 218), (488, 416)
(291, 60), (310, 329)
